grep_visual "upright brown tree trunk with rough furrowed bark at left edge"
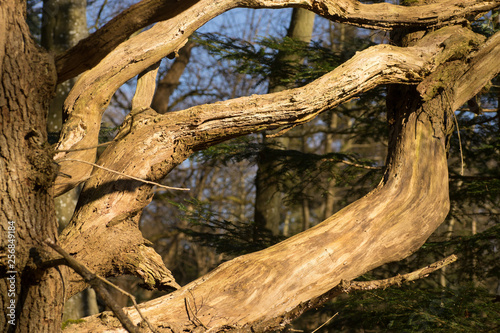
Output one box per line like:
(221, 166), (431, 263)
(0, 0), (64, 332)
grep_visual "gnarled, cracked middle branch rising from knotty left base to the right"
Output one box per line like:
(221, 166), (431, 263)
(56, 27), (482, 308)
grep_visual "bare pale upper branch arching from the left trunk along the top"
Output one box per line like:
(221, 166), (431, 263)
(54, 0), (500, 196)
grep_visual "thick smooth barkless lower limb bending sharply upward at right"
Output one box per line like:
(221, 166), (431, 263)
(61, 68), (449, 332)
